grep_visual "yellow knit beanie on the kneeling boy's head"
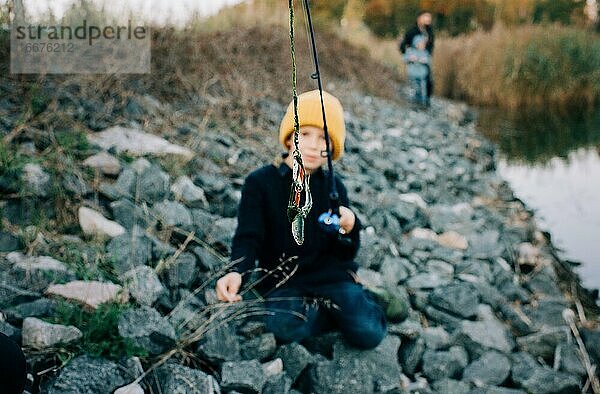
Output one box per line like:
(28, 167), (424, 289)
(279, 90), (346, 160)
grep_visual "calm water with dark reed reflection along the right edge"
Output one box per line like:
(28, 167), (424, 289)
(478, 110), (600, 288)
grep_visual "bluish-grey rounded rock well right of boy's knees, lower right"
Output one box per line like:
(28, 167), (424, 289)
(429, 282), (479, 319)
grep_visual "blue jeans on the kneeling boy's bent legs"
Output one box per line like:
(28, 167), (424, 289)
(265, 282), (387, 349)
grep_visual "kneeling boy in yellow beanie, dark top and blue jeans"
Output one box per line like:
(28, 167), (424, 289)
(216, 90), (387, 349)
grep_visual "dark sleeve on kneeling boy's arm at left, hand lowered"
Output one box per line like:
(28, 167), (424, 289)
(230, 174), (265, 274)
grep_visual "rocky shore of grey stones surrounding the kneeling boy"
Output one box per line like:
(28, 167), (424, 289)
(0, 82), (600, 394)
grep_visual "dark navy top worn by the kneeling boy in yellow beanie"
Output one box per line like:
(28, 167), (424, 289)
(231, 163), (361, 293)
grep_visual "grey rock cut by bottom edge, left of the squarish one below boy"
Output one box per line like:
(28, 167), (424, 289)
(156, 362), (221, 394)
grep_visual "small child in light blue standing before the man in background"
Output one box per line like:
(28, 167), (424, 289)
(404, 34), (431, 106)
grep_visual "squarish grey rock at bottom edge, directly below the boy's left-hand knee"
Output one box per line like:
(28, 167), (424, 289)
(221, 360), (267, 393)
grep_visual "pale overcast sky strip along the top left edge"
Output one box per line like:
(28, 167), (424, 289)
(5, 0), (243, 25)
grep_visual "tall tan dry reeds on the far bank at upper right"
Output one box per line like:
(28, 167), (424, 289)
(433, 25), (600, 112)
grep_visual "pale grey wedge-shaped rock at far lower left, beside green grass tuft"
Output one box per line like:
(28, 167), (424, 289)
(21, 317), (83, 349)
